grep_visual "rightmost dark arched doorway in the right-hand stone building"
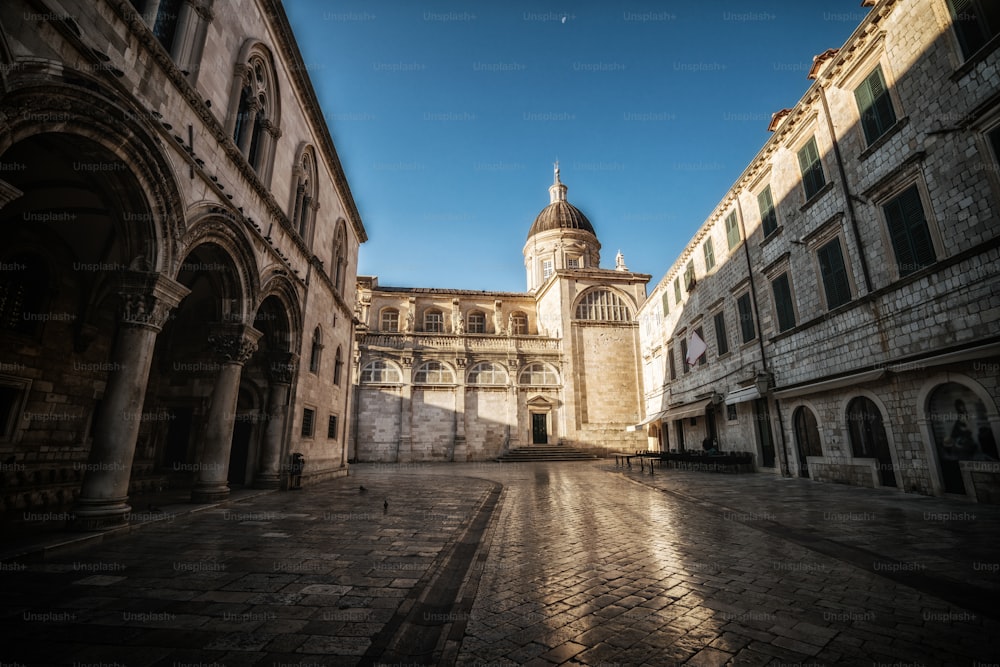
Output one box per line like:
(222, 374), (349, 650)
(927, 382), (998, 495)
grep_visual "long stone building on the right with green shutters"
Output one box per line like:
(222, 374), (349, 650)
(638, 0), (1000, 502)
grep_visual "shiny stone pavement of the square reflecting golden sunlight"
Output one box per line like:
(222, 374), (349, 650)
(0, 461), (1000, 667)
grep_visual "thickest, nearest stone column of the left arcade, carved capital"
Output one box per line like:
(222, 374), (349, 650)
(72, 271), (190, 530)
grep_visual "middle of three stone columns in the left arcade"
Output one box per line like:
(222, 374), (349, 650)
(191, 324), (263, 503)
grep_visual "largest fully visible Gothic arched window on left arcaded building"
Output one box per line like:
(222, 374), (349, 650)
(231, 43), (282, 183)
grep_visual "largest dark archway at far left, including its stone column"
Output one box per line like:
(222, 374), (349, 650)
(0, 130), (173, 528)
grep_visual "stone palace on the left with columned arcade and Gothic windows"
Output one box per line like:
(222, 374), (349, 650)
(0, 0), (366, 528)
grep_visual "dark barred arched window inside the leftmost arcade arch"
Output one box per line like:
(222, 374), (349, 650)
(0, 254), (49, 336)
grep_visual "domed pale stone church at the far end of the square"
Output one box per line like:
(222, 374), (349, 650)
(351, 167), (650, 462)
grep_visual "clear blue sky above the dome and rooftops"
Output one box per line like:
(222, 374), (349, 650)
(285, 0), (868, 292)
